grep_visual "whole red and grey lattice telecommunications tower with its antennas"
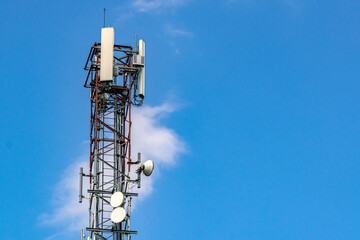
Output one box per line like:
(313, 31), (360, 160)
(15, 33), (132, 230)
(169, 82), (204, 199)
(79, 27), (154, 240)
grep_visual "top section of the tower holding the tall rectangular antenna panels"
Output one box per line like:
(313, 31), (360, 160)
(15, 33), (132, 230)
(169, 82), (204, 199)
(84, 27), (145, 105)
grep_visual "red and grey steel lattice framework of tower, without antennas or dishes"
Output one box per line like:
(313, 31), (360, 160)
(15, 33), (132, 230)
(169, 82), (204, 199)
(80, 43), (143, 240)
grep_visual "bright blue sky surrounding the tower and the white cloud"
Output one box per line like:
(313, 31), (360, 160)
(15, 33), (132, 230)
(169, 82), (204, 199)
(0, 0), (360, 240)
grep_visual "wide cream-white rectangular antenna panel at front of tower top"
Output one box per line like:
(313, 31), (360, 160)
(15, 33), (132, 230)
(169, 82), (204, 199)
(100, 27), (114, 81)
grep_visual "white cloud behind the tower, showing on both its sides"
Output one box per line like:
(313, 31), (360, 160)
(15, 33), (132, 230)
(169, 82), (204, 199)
(39, 104), (185, 239)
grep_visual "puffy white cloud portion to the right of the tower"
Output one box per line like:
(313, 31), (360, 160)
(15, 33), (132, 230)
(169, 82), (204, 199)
(132, 104), (185, 199)
